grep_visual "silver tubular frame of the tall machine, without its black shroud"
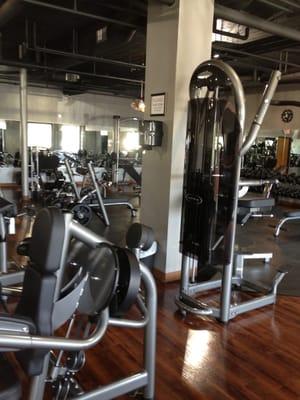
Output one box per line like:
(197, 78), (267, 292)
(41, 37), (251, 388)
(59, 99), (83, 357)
(176, 60), (285, 322)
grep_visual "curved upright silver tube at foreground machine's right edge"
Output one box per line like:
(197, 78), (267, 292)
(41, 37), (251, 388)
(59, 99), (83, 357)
(140, 261), (157, 399)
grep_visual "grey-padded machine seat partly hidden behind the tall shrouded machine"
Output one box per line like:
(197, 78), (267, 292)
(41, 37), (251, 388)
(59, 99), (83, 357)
(238, 179), (278, 226)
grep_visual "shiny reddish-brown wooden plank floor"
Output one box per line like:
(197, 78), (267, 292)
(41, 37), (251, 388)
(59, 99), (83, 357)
(4, 195), (300, 400)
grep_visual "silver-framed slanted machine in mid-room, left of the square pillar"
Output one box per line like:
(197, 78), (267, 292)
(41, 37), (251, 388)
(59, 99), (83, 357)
(65, 159), (137, 226)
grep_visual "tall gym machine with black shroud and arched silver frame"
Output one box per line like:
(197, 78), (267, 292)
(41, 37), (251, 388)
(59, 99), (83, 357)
(176, 60), (285, 322)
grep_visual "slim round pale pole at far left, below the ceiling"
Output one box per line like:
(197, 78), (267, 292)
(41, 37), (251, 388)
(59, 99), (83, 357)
(20, 68), (29, 200)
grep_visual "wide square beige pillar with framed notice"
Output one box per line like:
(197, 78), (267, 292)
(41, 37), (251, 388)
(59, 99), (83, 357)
(141, 0), (214, 280)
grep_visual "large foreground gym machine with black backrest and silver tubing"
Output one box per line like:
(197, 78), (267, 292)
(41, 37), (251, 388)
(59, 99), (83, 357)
(0, 207), (157, 400)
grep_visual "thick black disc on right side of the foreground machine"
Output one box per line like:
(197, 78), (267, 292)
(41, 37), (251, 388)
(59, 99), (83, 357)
(110, 247), (141, 314)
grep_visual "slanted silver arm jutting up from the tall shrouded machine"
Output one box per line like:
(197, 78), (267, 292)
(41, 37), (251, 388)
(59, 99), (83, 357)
(240, 70), (282, 157)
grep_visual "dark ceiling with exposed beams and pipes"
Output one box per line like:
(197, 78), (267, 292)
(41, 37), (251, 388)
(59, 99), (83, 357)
(0, 0), (300, 97)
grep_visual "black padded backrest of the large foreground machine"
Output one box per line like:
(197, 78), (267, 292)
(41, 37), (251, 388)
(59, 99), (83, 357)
(16, 207), (65, 375)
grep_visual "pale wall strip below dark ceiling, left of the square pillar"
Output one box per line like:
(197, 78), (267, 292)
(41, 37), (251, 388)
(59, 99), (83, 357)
(0, 84), (141, 129)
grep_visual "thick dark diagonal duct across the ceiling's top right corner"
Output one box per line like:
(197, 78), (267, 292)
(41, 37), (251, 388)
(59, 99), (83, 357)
(215, 4), (300, 42)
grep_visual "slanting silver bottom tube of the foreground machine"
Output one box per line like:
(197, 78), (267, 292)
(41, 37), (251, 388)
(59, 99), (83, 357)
(74, 372), (150, 400)
